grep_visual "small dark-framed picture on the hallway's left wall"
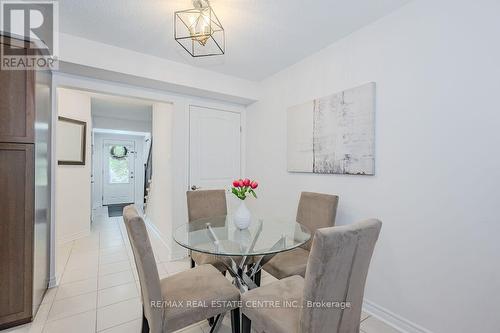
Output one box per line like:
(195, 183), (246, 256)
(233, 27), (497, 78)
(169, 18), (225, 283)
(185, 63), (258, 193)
(57, 117), (87, 165)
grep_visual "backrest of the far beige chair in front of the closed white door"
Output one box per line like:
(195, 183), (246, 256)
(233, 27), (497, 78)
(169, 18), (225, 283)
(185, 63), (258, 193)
(186, 190), (227, 222)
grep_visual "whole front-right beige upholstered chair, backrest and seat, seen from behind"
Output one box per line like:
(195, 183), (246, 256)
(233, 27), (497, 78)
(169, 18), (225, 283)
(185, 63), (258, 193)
(241, 219), (382, 333)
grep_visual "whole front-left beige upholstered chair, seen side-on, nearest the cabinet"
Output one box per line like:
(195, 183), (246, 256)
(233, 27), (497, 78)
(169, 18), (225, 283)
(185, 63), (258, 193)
(123, 205), (240, 333)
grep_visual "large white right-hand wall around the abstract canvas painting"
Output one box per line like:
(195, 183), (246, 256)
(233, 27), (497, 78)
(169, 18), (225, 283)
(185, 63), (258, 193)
(247, 0), (500, 333)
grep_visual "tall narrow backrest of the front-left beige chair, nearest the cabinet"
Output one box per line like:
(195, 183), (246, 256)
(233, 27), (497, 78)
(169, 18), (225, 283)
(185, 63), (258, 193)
(123, 205), (164, 333)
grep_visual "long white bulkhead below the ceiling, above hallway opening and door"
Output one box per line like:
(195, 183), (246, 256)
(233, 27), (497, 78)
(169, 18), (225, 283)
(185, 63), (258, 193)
(59, 33), (260, 103)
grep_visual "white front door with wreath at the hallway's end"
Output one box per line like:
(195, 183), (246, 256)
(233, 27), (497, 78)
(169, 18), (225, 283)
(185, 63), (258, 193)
(102, 140), (135, 205)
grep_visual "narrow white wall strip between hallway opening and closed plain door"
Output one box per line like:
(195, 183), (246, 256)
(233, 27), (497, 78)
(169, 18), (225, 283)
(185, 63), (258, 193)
(146, 103), (174, 250)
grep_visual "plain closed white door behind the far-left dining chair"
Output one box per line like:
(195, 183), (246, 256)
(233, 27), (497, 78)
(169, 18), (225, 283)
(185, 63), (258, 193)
(189, 106), (241, 190)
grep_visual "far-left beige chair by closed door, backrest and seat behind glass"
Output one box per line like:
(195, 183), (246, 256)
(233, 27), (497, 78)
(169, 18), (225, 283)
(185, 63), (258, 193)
(186, 190), (232, 272)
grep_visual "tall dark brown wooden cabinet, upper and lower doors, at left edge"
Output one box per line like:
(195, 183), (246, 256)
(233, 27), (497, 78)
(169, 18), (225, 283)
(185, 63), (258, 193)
(0, 38), (35, 330)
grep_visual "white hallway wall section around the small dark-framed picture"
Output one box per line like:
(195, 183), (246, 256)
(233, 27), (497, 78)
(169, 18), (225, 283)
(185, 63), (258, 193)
(55, 88), (92, 243)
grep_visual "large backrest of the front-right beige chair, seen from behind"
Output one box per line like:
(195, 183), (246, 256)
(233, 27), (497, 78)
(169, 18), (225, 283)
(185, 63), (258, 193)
(300, 219), (382, 333)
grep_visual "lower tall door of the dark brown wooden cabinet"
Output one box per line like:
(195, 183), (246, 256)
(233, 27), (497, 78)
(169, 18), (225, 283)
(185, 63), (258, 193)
(0, 143), (34, 329)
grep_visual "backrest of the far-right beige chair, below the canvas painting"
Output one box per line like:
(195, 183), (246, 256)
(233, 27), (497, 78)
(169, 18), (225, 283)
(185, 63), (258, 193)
(297, 192), (339, 250)
